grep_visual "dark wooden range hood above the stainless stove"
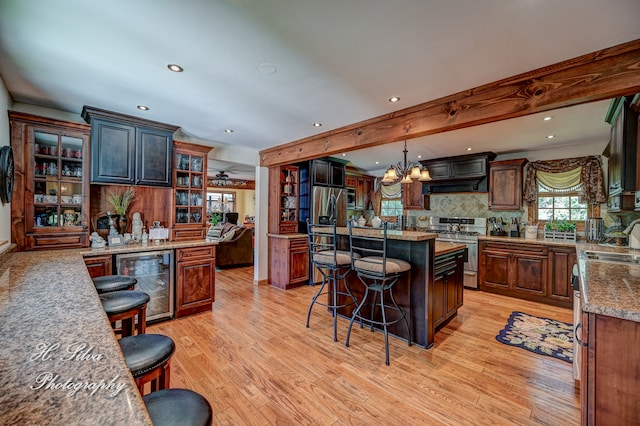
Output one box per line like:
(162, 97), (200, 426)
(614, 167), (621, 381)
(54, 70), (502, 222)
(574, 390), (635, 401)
(421, 152), (496, 194)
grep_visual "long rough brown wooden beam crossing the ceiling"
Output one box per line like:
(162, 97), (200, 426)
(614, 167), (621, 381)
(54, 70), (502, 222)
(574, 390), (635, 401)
(260, 39), (640, 167)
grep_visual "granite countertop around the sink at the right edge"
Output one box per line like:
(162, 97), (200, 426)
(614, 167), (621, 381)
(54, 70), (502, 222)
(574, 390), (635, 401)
(577, 243), (640, 322)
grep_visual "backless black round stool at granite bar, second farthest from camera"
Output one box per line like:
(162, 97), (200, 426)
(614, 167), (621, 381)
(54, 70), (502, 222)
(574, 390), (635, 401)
(100, 290), (150, 337)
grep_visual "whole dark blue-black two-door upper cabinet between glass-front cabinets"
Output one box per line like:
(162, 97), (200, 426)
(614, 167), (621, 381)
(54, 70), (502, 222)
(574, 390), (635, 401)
(82, 106), (178, 187)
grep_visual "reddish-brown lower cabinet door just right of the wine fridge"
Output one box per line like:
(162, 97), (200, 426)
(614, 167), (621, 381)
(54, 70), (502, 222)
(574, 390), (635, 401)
(176, 250), (216, 317)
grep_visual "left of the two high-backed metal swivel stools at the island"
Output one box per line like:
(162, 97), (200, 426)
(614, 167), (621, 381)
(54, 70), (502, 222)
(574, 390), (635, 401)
(307, 219), (358, 342)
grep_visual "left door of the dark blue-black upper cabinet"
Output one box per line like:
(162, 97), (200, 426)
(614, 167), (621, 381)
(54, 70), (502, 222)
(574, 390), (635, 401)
(91, 119), (136, 185)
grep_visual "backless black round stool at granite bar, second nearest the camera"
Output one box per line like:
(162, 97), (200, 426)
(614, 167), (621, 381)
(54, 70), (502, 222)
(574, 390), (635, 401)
(118, 334), (176, 395)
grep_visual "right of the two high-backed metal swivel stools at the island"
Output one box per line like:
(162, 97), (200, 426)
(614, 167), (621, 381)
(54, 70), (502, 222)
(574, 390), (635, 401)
(345, 222), (411, 365)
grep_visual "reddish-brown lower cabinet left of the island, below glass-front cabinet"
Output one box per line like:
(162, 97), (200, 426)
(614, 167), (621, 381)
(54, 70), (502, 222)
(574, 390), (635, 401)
(269, 234), (309, 290)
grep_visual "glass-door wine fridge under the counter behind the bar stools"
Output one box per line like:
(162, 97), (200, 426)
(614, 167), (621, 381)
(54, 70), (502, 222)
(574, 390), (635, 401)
(116, 250), (174, 321)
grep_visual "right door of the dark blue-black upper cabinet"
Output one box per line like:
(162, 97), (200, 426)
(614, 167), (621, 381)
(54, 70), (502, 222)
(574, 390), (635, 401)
(136, 127), (173, 186)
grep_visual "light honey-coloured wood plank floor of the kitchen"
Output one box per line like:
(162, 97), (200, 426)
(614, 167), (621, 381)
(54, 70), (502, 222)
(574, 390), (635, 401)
(147, 267), (580, 425)
